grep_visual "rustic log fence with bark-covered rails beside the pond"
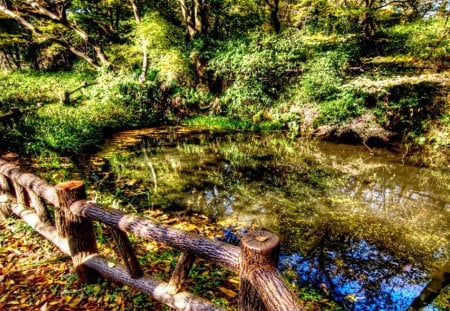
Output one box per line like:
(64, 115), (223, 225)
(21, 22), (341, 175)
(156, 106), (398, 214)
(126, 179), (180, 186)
(0, 159), (303, 311)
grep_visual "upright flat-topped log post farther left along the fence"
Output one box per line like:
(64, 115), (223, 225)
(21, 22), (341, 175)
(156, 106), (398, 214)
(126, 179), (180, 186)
(55, 180), (98, 284)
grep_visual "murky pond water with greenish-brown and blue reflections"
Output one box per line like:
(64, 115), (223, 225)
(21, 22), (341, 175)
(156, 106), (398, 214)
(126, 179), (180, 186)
(81, 128), (450, 310)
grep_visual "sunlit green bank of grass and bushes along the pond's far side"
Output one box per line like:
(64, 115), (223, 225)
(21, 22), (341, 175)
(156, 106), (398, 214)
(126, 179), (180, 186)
(0, 17), (450, 166)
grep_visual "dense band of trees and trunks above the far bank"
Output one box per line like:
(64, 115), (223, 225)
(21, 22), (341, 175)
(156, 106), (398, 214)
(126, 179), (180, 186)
(0, 0), (449, 71)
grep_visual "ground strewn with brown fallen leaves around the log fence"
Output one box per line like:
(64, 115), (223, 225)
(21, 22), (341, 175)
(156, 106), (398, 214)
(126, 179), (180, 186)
(0, 207), (239, 311)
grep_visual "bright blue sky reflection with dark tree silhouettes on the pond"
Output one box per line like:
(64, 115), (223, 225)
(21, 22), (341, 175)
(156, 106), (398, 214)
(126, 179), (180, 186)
(280, 232), (426, 310)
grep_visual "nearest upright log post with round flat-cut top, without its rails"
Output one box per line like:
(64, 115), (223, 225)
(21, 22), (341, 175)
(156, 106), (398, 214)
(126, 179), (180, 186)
(238, 231), (280, 311)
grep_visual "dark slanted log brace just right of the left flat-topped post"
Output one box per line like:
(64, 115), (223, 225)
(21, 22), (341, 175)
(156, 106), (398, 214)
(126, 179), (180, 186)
(108, 226), (144, 279)
